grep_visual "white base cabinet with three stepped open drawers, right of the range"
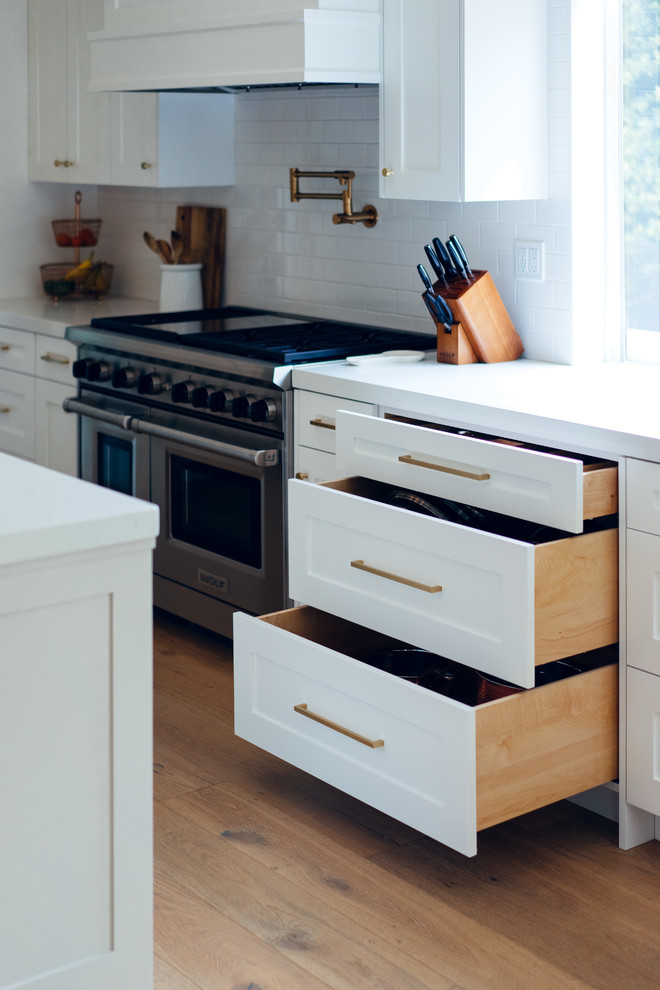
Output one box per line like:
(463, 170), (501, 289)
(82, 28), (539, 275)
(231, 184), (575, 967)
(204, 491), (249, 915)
(234, 406), (618, 855)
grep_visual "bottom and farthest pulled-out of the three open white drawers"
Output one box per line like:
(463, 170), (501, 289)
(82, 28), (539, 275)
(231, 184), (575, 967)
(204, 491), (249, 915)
(234, 606), (618, 856)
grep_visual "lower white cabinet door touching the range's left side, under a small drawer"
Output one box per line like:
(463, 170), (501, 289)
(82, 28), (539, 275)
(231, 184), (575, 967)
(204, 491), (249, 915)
(35, 378), (78, 478)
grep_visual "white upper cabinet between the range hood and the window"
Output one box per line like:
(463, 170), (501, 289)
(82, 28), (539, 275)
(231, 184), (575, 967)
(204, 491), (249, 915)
(380, 0), (548, 202)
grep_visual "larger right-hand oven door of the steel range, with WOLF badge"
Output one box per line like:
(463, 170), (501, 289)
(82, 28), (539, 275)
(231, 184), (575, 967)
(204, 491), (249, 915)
(151, 416), (287, 614)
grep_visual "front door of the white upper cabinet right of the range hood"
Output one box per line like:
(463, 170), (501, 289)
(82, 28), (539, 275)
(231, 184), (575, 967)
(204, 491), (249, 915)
(380, 0), (461, 201)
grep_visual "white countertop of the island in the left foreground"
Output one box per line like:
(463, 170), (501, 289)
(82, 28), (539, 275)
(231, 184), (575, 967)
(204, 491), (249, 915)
(0, 454), (158, 566)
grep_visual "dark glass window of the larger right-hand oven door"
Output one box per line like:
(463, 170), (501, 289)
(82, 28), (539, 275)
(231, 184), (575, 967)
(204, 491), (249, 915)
(170, 456), (261, 567)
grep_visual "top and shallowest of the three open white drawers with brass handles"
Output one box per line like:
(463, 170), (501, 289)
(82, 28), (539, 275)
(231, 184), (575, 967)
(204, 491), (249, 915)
(336, 410), (617, 533)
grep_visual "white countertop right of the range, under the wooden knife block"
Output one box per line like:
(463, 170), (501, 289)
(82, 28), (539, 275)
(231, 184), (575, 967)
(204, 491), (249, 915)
(292, 353), (660, 461)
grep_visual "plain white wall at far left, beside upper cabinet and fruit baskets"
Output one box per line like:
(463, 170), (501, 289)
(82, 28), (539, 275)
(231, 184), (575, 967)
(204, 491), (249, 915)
(0, 0), (77, 299)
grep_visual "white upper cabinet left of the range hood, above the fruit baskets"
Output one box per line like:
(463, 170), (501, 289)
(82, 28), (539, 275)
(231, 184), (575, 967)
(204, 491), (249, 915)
(28, 0), (234, 187)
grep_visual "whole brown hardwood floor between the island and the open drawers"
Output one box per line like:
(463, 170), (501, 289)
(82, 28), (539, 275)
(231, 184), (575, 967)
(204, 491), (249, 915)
(154, 613), (660, 990)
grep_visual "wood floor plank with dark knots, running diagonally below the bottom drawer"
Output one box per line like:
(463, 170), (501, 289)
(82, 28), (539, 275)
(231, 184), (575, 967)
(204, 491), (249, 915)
(161, 782), (600, 990)
